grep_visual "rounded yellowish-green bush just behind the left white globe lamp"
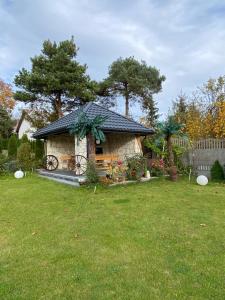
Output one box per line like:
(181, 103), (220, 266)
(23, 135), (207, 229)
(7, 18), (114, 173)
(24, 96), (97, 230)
(17, 143), (34, 171)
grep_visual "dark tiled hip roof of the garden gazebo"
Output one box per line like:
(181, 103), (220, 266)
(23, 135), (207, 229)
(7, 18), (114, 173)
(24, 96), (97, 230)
(33, 102), (154, 139)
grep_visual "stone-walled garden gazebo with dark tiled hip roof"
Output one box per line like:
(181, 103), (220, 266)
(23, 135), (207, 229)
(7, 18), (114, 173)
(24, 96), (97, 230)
(33, 102), (153, 169)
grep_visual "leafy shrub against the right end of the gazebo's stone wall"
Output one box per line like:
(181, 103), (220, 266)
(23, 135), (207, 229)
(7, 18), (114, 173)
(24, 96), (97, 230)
(126, 154), (147, 180)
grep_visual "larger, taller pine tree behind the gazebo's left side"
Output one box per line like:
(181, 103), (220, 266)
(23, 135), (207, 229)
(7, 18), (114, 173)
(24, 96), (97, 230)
(14, 37), (96, 119)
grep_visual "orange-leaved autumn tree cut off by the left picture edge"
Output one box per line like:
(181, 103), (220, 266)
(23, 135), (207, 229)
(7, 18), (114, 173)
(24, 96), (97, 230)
(0, 79), (15, 113)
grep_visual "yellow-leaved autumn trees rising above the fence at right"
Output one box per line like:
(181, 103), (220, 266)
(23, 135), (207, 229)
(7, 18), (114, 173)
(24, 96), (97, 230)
(173, 76), (225, 140)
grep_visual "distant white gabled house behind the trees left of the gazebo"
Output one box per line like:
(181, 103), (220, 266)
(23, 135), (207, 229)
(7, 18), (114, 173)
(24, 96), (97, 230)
(14, 110), (37, 140)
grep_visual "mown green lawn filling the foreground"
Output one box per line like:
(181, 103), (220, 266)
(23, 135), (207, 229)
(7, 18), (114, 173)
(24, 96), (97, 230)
(0, 176), (225, 300)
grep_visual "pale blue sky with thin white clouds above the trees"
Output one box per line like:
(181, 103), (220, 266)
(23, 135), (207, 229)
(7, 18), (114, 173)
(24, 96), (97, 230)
(0, 0), (225, 118)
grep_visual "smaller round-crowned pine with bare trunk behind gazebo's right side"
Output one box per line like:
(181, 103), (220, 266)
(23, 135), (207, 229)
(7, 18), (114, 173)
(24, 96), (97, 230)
(99, 57), (165, 117)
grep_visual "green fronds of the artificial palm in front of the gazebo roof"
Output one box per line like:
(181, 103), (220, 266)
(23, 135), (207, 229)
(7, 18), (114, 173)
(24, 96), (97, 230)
(69, 112), (107, 142)
